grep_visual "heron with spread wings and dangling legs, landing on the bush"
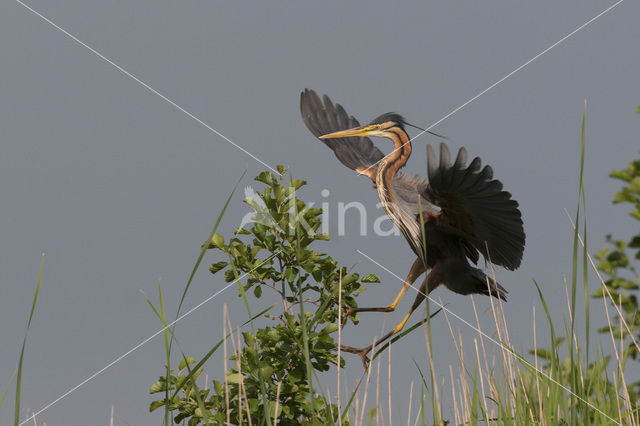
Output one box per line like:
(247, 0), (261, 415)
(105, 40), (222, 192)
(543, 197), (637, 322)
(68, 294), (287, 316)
(300, 89), (525, 367)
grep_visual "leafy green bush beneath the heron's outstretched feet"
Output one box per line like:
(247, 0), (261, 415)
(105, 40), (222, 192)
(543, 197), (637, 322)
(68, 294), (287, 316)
(150, 166), (379, 425)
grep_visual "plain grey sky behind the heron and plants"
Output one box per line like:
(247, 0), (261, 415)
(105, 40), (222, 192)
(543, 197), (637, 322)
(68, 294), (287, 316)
(0, 0), (640, 425)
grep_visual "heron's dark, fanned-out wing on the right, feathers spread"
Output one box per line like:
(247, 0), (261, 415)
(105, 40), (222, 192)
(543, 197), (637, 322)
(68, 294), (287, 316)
(424, 143), (525, 269)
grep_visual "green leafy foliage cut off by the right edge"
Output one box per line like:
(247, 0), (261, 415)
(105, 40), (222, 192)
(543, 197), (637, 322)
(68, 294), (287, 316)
(594, 159), (640, 364)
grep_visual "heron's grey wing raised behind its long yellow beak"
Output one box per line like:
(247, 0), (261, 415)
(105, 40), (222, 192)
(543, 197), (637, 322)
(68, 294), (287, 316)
(300, 89), (384, 183)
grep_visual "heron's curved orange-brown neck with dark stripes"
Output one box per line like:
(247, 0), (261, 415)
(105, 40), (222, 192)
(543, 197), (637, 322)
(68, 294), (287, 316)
(376, 127), (411, 207)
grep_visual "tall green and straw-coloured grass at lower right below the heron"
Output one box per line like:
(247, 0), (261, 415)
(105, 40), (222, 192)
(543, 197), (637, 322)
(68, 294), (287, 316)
(332, 258), (640, 425)
